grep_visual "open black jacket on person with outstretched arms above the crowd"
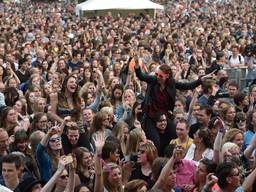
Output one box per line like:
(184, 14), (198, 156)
(135, 68), (202, 113)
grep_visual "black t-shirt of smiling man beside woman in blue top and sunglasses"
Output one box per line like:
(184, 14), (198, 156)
(61, 133), (91, 155)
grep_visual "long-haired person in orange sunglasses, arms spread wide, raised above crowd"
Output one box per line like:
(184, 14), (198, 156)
(135, 56), (212, 148)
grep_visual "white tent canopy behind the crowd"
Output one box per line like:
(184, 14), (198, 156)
(76, 0), (164, 15)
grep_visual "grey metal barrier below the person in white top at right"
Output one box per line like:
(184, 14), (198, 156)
(224, 67), (248, 90)
